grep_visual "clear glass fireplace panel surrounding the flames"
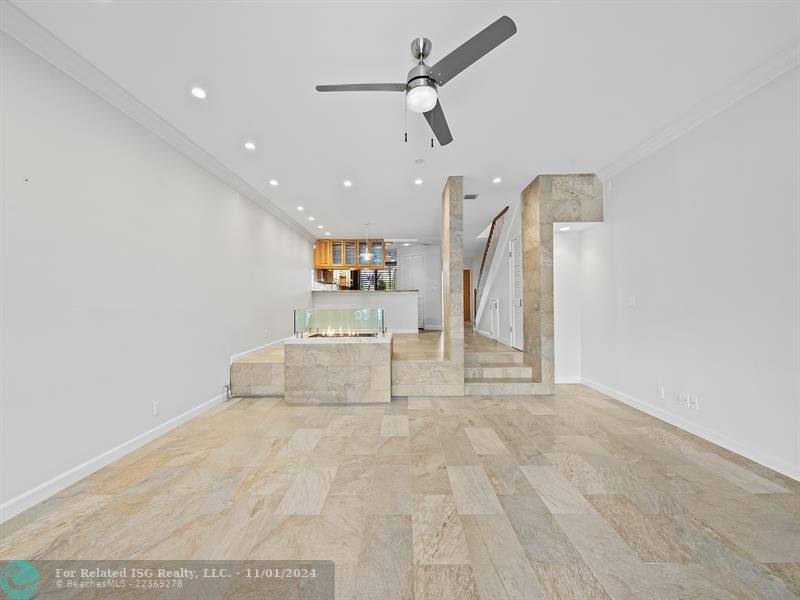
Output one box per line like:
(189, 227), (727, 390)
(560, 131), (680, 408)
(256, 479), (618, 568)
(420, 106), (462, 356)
(294, 308), (386, 338)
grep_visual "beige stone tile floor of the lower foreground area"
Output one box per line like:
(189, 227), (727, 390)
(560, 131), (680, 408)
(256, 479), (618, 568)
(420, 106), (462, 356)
(0, 386), (800, 600)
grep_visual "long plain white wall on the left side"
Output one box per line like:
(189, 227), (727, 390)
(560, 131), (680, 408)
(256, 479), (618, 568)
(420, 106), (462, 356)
(0, 37), (312, 515)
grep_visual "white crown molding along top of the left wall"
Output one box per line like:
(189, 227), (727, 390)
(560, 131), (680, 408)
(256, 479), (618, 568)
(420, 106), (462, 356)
(0, 0), (315, 240)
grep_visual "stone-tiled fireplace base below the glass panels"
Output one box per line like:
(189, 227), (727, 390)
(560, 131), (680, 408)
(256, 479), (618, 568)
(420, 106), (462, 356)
(284, 334), (392, 404)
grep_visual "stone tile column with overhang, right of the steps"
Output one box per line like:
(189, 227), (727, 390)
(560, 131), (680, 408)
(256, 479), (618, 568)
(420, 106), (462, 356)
(521, 174), (603, 394)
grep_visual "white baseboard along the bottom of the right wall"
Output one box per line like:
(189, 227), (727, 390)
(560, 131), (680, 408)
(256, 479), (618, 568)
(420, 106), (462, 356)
(582, 377), (800, 481)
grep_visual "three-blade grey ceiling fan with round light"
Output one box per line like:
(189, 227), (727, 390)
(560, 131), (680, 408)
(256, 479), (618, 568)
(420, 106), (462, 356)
(317, 17), (517, 146)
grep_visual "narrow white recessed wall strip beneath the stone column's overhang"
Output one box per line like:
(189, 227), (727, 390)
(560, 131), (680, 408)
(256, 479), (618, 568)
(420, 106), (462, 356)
(553, 226), (582, 383)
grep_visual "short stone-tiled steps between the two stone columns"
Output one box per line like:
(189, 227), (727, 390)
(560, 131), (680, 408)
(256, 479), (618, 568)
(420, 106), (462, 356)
(464, 350), (540, 396)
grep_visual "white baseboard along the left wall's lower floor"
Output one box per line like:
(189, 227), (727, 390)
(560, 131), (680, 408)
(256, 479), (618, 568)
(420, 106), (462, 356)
(0, 394), (225, 523)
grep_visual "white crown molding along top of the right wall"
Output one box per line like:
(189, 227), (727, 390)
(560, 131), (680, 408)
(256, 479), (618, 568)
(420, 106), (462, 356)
(597, 41), (800, 181)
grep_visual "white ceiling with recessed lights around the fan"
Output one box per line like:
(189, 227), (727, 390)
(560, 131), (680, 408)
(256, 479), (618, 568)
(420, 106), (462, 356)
(7, 0), (800, 255)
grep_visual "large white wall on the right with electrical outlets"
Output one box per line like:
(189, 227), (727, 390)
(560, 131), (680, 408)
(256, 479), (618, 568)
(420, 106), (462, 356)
(581, 68), (800, 478)
